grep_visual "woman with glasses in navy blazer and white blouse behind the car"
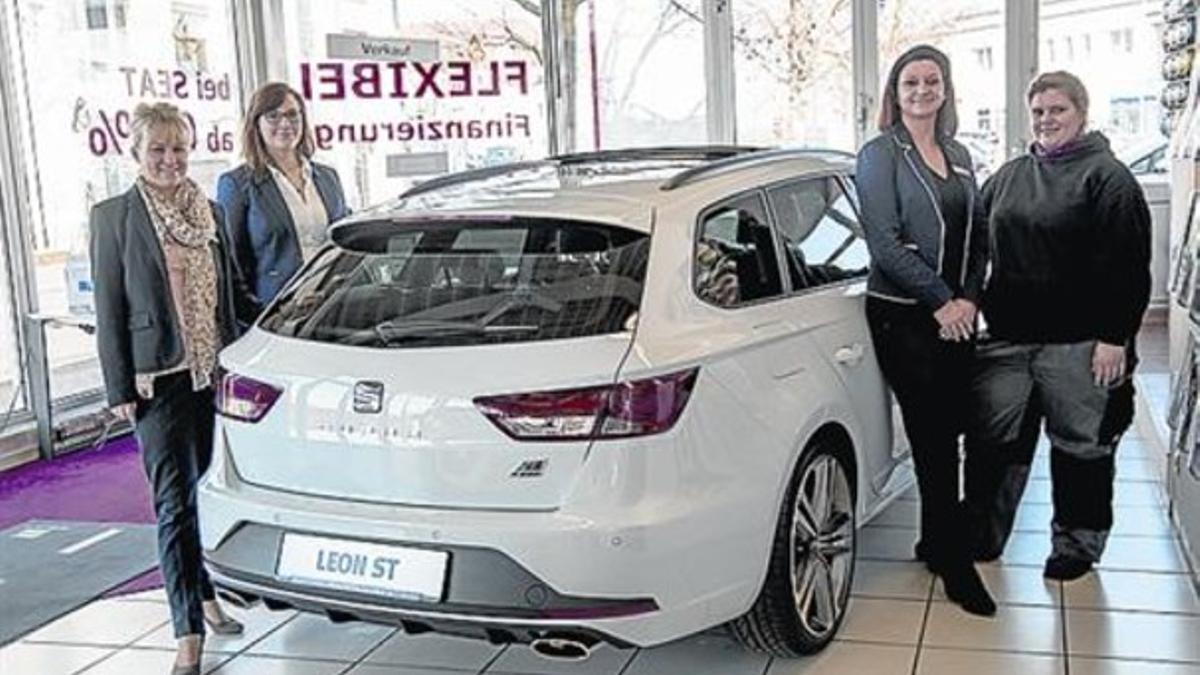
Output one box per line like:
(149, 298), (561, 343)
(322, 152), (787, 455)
(217, 82), (349, 305)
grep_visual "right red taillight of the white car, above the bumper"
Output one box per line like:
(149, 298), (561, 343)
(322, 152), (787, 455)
(475, 368), (700, 441)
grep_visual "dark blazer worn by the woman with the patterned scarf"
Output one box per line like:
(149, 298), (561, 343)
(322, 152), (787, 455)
(90, 187), (257, 406)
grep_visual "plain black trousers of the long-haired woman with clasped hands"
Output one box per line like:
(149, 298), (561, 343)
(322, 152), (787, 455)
(866, 298), (973, 566)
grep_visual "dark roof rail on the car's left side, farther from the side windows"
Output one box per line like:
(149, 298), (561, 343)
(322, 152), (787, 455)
(400, 145), (763, 199)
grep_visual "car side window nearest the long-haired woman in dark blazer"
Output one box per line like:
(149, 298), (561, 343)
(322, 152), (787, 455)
(767, 172), (870, 291)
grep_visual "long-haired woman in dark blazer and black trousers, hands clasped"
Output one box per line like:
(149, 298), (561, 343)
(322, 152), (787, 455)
(856, 44), (996, 615)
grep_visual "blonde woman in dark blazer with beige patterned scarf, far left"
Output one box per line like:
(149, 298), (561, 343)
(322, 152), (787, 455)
(91, 103), (254, 675)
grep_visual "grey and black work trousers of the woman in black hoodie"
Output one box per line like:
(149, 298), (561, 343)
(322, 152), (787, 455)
(965, 340), (1136, 562)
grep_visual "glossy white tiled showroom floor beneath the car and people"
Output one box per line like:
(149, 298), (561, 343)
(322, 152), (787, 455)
(0, 338), (1200, 675)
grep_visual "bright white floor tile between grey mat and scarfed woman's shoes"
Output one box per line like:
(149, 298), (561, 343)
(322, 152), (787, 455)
(25, 601), (170, 646)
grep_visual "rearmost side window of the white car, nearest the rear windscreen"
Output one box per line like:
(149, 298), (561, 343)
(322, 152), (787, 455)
(695, 195), (784, 307)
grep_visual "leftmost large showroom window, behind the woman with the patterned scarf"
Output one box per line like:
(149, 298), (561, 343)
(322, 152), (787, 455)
(0, 0), (239, 402)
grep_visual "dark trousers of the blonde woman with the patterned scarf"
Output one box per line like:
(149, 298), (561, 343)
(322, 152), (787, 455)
(134, 372), (215, 638)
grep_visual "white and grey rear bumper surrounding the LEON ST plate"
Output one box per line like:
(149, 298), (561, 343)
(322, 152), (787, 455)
(198, 449), (770, 646)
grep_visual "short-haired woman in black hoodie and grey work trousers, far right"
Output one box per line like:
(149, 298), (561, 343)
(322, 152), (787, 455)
(966, 71), (1150, 580)
